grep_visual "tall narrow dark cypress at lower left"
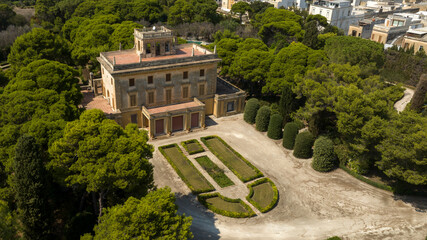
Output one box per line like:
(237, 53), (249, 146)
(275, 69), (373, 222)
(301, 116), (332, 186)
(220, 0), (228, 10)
(13, 135), (52, 239)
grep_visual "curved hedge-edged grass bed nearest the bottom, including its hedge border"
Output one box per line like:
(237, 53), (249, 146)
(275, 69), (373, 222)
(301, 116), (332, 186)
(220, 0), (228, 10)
(197, 193), (255, 218)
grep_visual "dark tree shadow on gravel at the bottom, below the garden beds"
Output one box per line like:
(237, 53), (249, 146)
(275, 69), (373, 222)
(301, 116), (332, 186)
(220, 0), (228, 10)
(175, 193), (220, 240)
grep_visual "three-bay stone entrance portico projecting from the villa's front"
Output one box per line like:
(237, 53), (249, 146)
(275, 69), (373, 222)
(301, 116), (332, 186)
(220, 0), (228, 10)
(142, 98), (205, 138)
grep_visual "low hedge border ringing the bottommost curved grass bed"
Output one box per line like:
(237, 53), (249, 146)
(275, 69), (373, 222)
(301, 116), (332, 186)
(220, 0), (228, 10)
(197, 193), (255, 218)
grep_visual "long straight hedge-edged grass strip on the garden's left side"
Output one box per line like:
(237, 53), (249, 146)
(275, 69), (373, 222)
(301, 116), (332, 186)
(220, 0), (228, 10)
(159, 143), (215, 194)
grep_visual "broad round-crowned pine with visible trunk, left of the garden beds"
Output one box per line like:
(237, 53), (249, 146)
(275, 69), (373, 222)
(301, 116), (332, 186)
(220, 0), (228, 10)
(48, 109), (153, 213)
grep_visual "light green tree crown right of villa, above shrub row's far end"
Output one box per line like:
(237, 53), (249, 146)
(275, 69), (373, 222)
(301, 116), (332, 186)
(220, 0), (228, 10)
(262, 43), (326, 94)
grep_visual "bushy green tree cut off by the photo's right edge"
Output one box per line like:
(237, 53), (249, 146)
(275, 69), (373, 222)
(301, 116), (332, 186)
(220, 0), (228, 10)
(376, 111), (427, 185)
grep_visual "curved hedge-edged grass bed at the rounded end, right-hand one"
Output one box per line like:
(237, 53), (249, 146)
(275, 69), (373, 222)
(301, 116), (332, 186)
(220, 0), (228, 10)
(246, 178), (279, 213)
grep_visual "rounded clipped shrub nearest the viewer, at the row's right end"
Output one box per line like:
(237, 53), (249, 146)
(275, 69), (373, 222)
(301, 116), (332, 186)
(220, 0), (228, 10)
(311, 136), (338, 172)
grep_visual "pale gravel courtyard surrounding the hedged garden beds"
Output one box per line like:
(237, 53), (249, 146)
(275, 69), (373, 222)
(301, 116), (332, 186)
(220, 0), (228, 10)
(150, 114), (427, 240)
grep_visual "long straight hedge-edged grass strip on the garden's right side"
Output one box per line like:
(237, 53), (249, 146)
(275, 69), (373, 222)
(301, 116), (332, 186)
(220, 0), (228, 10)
(202, 136), (263, 182)
